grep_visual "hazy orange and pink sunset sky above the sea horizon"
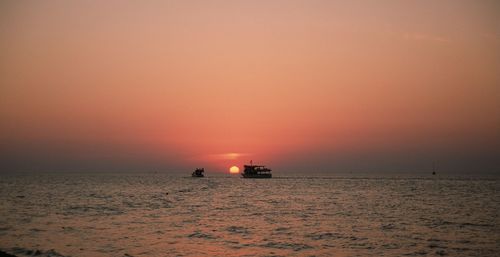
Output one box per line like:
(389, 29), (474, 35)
(0, 0), (500, 173)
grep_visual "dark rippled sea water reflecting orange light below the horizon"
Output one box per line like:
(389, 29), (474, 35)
(0, 173), (500, 256)
